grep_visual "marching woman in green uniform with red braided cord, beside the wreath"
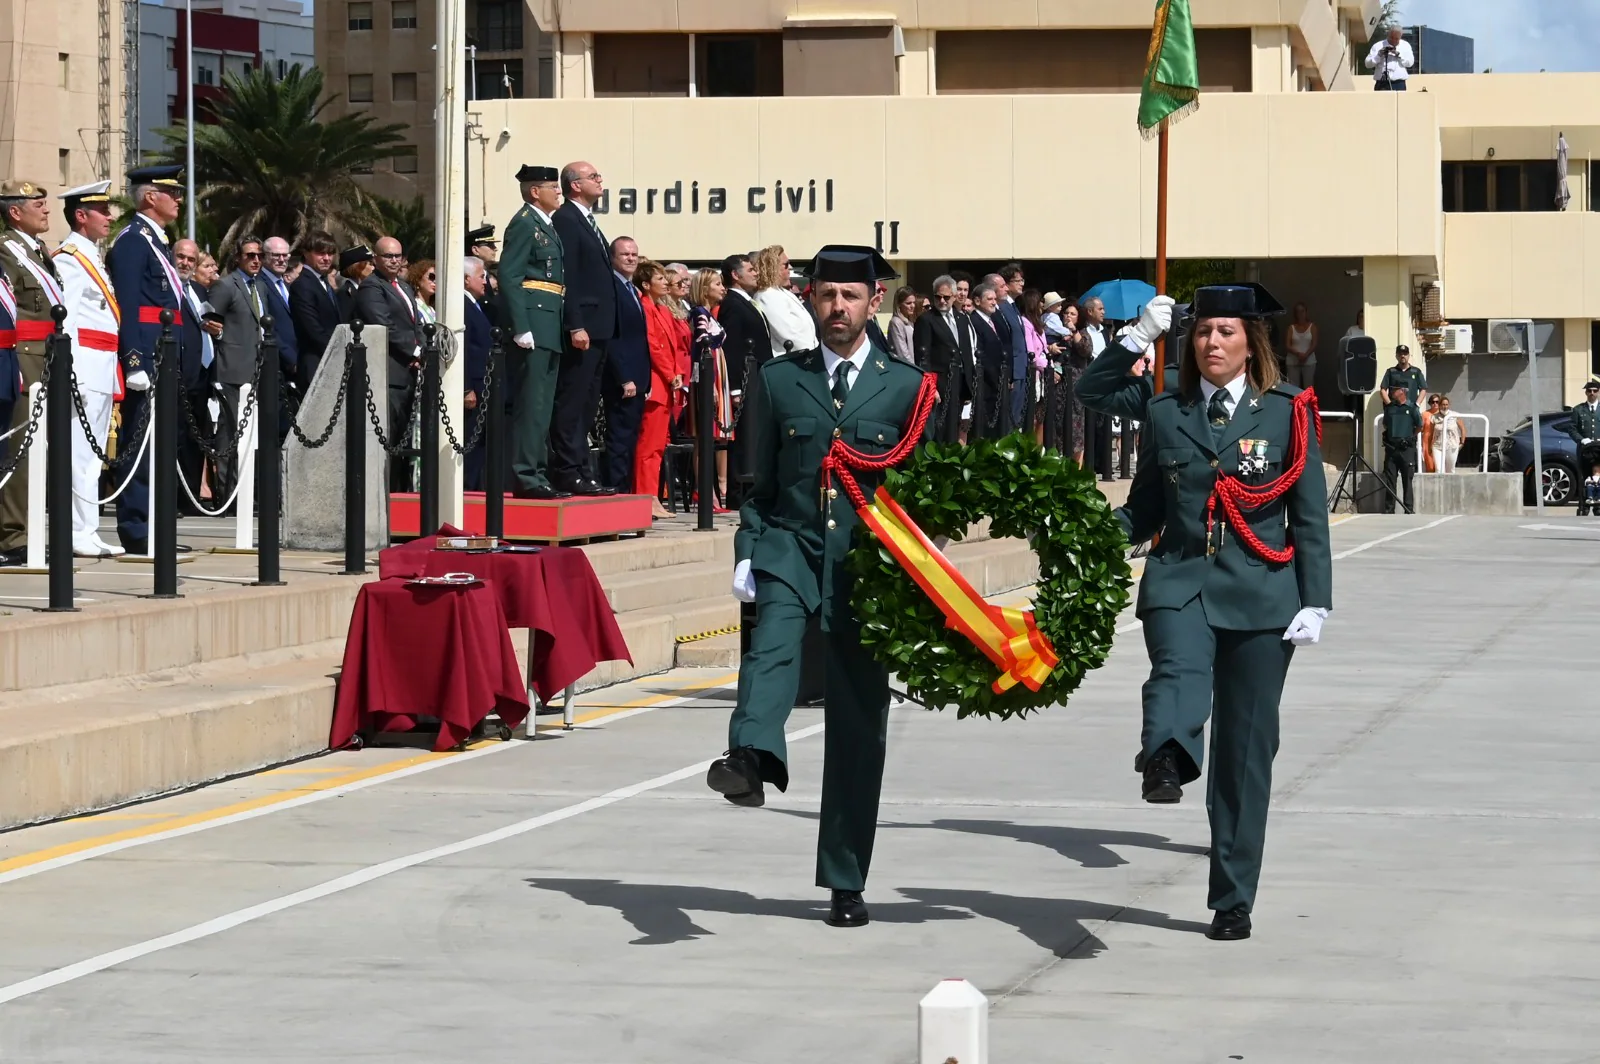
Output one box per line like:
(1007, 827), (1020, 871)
(1117, 285), (1333, 939)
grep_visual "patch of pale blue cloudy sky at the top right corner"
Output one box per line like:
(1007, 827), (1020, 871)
(1400, 0), (1600, 74)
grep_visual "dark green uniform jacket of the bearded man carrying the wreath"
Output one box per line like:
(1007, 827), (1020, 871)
(734, 347), (922, 632)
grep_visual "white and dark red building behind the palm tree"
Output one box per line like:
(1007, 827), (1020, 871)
(139, 0), (315, 152)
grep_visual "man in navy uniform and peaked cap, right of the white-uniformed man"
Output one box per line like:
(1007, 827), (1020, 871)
(106, 166), (184, 554)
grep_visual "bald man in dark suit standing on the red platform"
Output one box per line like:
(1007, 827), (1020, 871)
(550, 162), (616, 494)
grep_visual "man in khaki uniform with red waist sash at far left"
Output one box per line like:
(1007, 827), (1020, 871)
(0, 181), (64, 565)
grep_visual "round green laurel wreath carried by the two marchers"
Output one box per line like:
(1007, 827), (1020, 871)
(848, 434), (1133, 718)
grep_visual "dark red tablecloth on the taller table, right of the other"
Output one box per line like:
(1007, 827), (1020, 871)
(378, 526), (634, 702)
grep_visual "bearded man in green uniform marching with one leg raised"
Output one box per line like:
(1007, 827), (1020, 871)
(706, 245), (923, 926)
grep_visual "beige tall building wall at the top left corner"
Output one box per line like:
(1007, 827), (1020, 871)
(0, 0), (123, 240)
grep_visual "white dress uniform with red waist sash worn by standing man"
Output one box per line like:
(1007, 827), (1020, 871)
(54, 234), (120, 554)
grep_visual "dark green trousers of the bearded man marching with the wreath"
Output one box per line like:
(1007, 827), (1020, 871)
(728, 573), (890, 890)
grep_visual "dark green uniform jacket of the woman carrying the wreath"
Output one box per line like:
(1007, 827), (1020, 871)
(1117, 384), (1333, 630)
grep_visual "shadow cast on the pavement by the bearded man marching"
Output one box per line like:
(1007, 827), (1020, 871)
(525, 878), (971, 946)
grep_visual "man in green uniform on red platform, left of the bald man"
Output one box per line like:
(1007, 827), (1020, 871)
(499, 166), (573, 499)
